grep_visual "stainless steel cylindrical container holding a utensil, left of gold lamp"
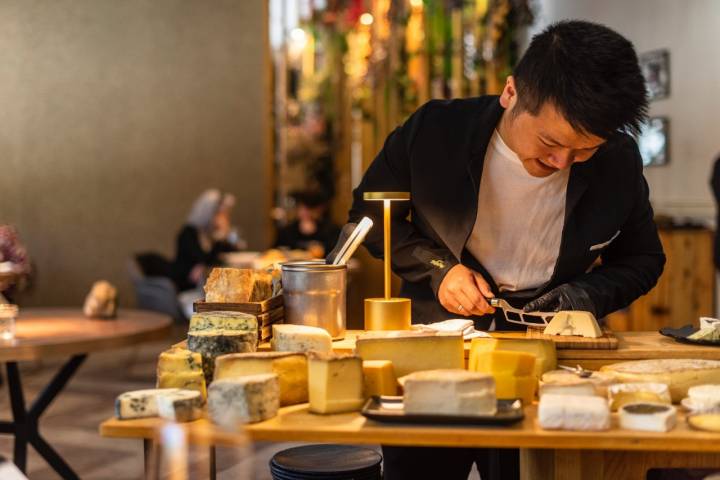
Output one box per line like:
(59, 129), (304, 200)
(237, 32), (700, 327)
(282, 260), (347, 340)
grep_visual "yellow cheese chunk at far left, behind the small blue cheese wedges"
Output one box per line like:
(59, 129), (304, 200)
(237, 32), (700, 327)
(157, 347), (207, 399)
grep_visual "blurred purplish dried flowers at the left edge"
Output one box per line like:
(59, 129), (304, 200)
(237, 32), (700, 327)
(0, 225), (32, 303)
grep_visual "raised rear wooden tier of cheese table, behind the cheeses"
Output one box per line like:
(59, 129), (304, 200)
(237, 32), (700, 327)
(258, 330), (720, 368)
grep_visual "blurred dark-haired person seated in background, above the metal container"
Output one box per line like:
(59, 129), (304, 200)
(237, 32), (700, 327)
(275, 192), (340, 258)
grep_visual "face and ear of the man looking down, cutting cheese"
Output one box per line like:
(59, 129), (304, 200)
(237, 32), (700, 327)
(498, 77), (605, 177)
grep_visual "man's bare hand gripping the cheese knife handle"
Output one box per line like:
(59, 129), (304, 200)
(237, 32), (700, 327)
(438, 264), (495, 317)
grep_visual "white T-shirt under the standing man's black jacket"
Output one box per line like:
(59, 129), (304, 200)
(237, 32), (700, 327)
(467, 130), (570, 291)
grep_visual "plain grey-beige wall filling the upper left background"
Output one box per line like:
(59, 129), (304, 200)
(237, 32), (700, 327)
(0, 0), (270, 305)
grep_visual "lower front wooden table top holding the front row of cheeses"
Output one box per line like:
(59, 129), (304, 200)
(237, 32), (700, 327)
(100, 404), (720, 452)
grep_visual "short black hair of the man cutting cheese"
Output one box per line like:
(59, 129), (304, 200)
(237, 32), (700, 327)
(513, 20), (648, 138)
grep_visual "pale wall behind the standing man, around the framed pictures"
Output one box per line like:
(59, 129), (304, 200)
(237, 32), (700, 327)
(530, 0), (720, 221)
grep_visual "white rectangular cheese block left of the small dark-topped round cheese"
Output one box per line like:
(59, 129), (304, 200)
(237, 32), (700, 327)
(538, 395), (610, 431)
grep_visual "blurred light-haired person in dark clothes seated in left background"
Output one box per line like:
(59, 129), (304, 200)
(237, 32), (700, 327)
(172, 189), (238, 292)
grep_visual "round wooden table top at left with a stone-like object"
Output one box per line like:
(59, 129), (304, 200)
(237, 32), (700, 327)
(0, 308), (172, 362)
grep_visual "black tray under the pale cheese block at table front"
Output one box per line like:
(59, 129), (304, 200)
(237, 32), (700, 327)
(360, 396), (525, 425)
